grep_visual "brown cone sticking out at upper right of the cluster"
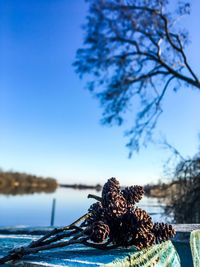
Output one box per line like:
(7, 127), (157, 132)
(122, 185), (144, 205)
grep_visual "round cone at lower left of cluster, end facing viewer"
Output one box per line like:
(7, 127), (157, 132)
(88, 221), (110, 243)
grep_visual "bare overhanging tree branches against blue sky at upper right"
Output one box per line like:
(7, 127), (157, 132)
(74, 0), (200, 155)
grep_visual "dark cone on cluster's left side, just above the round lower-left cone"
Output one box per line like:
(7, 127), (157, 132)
(85, 202), (104, 225)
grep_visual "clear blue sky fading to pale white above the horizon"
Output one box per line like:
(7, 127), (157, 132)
(0, 0), (200, 184)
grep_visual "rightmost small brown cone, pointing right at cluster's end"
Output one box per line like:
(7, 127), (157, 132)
(153, 223), (176, 243)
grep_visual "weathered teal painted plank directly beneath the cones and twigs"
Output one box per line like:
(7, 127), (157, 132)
(0, 228), (180, 267)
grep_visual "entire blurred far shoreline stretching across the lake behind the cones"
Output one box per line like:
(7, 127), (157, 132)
(0, 170), (170, 198)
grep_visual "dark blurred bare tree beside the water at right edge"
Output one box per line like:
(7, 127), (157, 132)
(165, 153), (200, 223)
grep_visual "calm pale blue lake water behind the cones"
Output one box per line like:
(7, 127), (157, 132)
(0, 188), (167, 226)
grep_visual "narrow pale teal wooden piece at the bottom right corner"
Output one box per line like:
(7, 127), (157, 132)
(190, 230), (200, 267)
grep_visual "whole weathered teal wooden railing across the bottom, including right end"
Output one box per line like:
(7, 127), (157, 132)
(0, 224), (200, 267)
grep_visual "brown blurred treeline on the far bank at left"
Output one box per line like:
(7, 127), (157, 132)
(0, 170), (58, 195)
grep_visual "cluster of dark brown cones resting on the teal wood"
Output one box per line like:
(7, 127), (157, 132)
(85, 178), (175, 250)
